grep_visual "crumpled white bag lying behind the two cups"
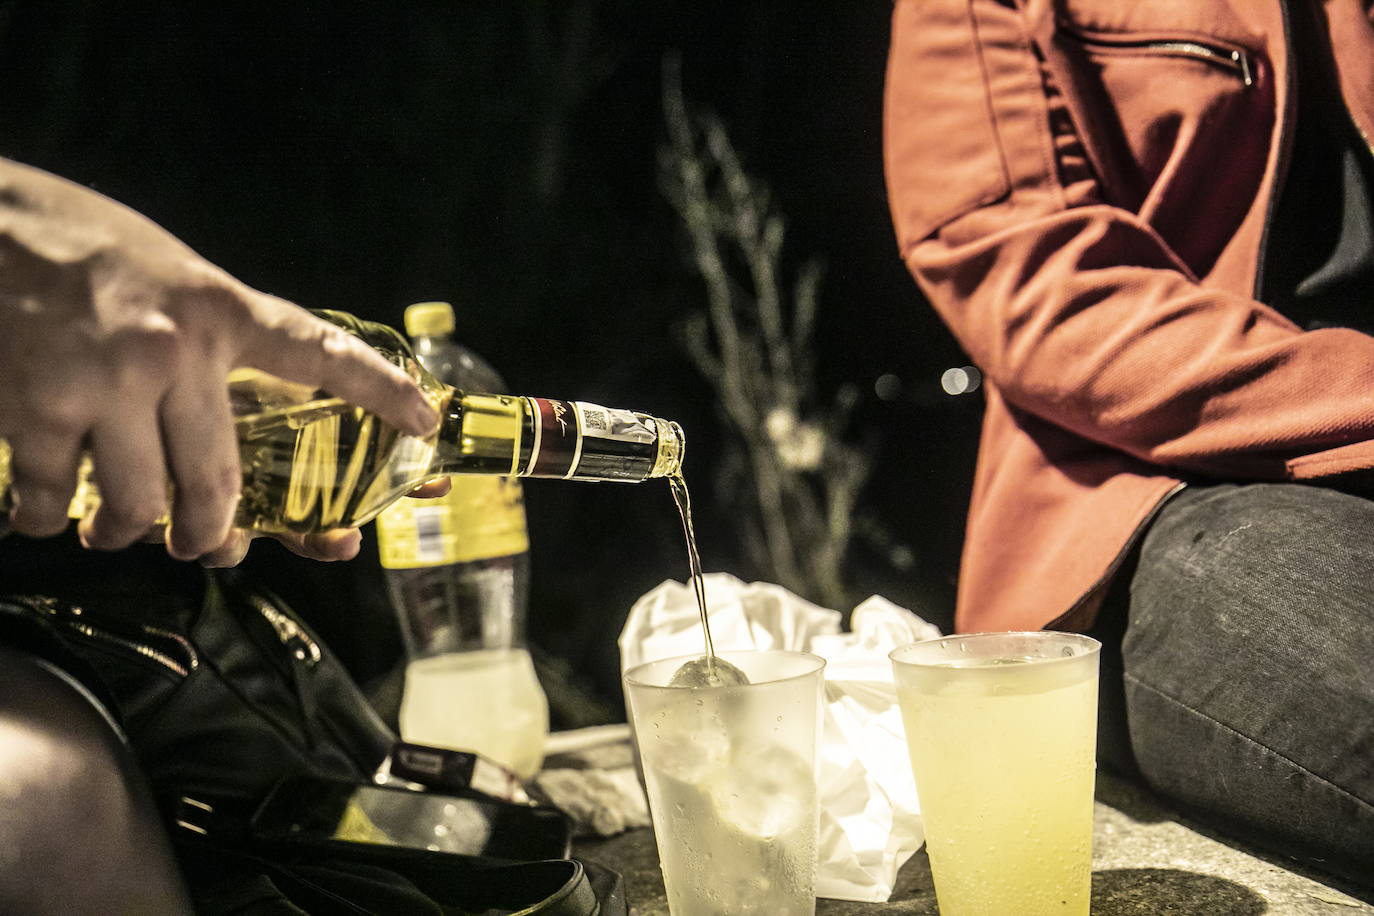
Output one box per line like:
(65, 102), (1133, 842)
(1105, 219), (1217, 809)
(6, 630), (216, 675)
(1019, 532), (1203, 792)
(620, 573), (940, 902)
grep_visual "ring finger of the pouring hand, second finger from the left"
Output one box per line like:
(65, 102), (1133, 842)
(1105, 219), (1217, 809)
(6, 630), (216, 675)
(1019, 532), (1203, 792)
(78, 404), (168, 551)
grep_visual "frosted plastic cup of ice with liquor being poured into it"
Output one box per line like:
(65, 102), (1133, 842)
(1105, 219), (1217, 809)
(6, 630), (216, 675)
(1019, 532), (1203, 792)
(625, 651), (826, 916)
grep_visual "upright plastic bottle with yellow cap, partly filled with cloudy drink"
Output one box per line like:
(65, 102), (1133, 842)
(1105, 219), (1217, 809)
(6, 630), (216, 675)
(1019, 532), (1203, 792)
(376, 302), (548, 779)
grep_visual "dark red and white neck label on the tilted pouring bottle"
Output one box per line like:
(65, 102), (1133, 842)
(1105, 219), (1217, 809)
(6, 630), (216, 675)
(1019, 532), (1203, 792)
(523, 398), (658, 479)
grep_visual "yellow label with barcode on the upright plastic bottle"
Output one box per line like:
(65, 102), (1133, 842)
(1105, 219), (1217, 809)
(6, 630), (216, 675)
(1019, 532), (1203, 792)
(376, 474), (529, 570)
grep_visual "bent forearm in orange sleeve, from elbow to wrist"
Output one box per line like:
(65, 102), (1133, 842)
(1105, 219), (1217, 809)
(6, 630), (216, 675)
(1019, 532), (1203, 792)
(907, 206), (1374, 479)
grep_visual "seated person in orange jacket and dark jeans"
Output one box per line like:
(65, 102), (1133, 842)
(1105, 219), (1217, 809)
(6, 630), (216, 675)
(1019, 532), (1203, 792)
(885, 0), (1374, 883)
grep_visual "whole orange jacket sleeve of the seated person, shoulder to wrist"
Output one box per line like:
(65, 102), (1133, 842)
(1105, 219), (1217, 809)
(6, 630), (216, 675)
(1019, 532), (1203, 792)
(883, 0), (1374, 479)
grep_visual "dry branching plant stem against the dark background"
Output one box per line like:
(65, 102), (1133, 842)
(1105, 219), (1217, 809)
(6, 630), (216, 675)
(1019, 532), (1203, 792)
(661, 59), (871, 608)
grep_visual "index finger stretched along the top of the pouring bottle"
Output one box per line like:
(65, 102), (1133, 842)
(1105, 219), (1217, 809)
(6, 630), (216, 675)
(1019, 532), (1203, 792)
(240, 294), (438, 435)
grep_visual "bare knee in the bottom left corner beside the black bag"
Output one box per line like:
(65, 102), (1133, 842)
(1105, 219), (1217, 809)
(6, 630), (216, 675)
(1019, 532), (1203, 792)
(0, 645), (192, 916)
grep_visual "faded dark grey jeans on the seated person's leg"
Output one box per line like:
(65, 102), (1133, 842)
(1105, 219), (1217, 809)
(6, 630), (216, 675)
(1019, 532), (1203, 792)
(1094, 483), (1374, 886)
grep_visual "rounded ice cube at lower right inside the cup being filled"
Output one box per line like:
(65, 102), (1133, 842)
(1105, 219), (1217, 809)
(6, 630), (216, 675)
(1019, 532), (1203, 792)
(709, 743), (816, 839)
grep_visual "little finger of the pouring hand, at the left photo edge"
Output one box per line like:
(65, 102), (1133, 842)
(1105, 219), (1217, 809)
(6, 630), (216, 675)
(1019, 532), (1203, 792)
(10, 430), (81, 537)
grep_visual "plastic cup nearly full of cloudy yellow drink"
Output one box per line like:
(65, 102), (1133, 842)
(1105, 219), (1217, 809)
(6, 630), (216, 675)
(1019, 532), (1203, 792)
(890, 632), (1101, 916)
